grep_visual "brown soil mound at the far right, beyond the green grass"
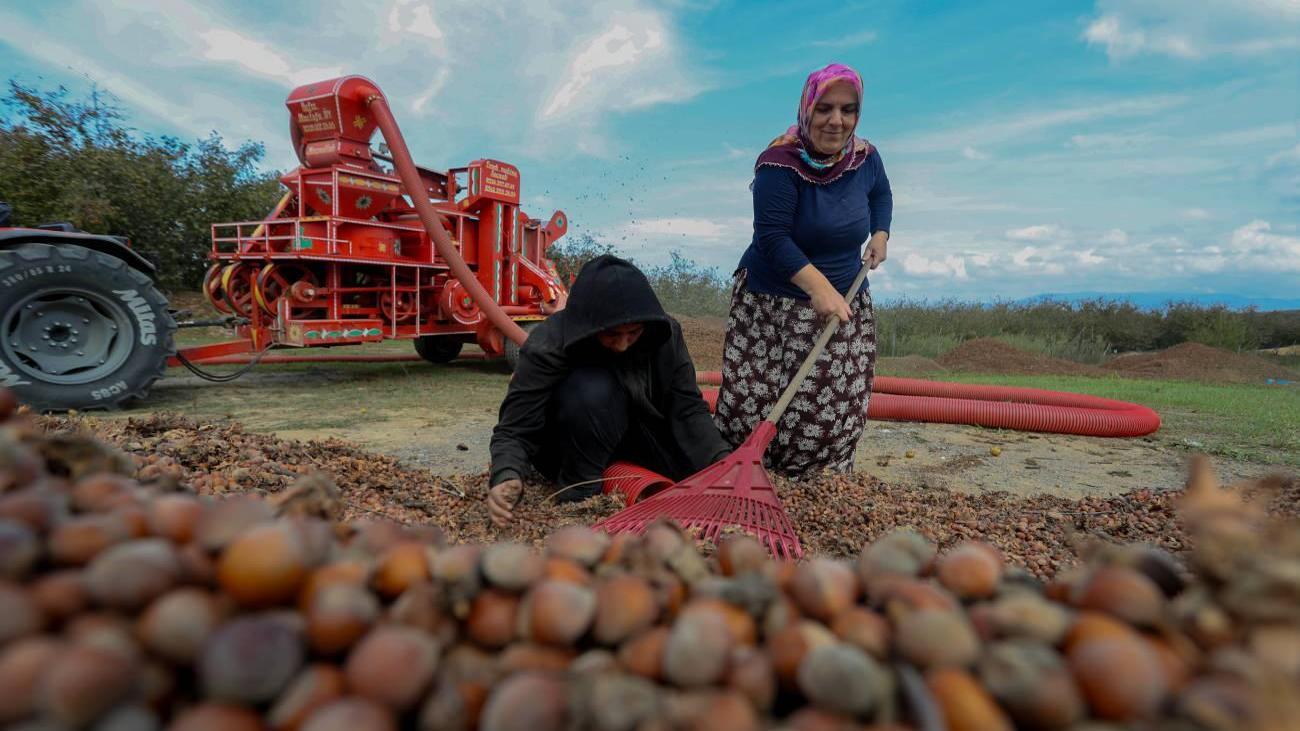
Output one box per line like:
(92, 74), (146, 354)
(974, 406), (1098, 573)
(1102, 342), (1300, 384)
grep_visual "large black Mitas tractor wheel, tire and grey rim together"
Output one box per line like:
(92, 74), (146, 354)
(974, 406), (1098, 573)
(0, 243), (176, 411)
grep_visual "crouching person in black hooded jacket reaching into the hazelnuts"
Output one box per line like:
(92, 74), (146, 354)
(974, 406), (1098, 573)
(488, 255), (729, 525)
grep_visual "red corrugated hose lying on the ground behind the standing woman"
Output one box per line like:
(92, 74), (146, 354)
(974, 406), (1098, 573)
(699, 371), (1160, 437)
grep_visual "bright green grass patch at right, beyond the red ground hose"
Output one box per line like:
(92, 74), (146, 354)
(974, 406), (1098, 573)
(943, 373), (1300, 468)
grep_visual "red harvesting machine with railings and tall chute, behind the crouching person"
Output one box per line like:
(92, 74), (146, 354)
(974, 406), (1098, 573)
(182, 75), (568, 366)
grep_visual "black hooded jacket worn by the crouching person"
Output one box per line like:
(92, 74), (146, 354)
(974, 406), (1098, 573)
(490, 255), (729, 485)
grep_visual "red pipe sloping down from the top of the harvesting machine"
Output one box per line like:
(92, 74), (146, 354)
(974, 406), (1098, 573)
(367, 87), (528, 345)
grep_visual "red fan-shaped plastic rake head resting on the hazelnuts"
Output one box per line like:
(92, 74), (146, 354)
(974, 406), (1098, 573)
(595, 421), (803, 558)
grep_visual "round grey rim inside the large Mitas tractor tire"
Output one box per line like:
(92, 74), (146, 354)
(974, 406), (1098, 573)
(0, 287), (135, 385)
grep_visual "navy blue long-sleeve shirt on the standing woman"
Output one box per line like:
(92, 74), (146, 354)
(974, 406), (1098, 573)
(740, 148), (893, 299)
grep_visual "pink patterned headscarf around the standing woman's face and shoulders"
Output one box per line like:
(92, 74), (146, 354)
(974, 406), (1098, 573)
(754, 64), (871, 185)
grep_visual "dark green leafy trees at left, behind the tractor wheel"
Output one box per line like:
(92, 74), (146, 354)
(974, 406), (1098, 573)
(0, 79), (280, 290)
